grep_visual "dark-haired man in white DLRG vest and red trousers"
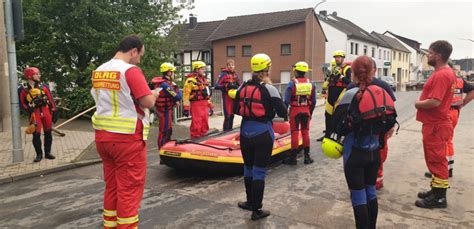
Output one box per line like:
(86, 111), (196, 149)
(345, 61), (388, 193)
(91, 35), (158, 228)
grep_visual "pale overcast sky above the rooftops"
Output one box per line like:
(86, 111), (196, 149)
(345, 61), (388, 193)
(183, 0), (474, 59)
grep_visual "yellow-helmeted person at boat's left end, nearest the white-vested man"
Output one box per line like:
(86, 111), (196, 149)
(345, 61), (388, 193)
(151, 63), (182, 148)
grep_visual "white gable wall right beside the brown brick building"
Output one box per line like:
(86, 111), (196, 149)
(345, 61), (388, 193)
(320, 21), (349, 63)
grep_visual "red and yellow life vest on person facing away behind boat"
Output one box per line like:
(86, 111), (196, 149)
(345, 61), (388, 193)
(291, 77), (313, 107)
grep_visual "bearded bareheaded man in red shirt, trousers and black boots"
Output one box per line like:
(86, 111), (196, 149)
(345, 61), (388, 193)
(415, 40), (456, 208)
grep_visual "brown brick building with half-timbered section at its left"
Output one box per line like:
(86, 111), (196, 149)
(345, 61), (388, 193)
(177, 8), (326, 83)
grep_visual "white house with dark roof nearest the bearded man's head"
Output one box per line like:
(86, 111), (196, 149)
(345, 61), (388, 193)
(383, 31), (424, 81)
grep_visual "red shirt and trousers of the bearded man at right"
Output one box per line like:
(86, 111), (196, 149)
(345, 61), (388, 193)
(416, 67), (456, 189)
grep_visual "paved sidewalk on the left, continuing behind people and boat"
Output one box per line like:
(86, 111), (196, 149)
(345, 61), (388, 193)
(0, 98), (324, 185)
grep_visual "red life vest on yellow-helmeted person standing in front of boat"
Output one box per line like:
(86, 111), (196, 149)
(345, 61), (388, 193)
(238, 82), (266, 118)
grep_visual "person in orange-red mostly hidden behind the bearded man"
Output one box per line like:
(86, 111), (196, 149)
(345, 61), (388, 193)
(425, 63), (474, 178)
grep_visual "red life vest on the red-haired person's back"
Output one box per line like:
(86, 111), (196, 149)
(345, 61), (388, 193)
(359, 85), (395, 120)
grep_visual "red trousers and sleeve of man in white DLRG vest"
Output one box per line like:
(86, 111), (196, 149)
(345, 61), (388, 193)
(95, 67), (151, 228)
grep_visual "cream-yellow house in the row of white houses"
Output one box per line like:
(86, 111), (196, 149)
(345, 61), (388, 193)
(371, 32), (410, 86)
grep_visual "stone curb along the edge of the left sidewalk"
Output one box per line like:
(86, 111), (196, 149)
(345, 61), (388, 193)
(0, 159), (102, 185)
